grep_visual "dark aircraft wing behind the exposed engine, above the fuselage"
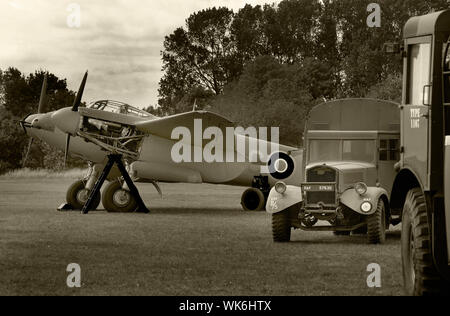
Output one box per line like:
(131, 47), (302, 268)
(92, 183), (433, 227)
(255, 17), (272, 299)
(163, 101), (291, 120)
(134, 111), (234, 139)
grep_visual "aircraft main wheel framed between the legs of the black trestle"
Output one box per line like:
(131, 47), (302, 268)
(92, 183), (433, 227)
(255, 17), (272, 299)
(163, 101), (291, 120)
(102, 181), (137, 213)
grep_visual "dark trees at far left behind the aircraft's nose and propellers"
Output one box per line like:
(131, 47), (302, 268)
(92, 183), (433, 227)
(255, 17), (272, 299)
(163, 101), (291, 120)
(0, 68), (79, 173)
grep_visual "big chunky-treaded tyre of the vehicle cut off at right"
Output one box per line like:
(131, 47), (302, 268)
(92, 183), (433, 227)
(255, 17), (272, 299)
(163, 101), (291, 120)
(402, 188), (448, 296)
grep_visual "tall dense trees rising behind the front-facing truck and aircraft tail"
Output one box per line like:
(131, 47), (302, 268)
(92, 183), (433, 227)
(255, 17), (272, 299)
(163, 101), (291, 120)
(158, 0), (448, 145)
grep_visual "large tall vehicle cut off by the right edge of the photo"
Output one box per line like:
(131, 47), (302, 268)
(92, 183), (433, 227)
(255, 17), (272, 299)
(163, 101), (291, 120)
(388, 10), (450, 295)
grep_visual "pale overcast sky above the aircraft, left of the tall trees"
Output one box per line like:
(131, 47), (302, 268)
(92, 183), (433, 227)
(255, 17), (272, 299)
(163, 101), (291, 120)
(0, 0), (275, 107)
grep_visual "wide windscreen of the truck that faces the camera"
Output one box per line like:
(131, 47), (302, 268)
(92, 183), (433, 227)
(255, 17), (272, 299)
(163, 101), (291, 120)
(309, 139), (376, 163)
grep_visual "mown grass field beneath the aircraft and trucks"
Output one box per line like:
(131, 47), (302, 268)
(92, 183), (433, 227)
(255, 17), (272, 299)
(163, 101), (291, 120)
(0, 177), (402, 296)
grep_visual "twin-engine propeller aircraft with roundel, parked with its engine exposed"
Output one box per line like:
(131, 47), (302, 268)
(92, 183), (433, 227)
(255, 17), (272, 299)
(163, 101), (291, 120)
(20, 72), (302, 212)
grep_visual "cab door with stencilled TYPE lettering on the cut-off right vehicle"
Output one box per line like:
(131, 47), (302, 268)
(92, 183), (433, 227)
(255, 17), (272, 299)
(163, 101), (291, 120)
(401, 36), (432, 190)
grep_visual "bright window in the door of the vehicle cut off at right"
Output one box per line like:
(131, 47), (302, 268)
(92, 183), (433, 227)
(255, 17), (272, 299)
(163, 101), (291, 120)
(408, 43), (431, 105)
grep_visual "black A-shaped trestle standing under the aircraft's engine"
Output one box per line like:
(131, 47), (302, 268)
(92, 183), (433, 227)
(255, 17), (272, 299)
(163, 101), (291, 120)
(81, 154), (150, 214)
